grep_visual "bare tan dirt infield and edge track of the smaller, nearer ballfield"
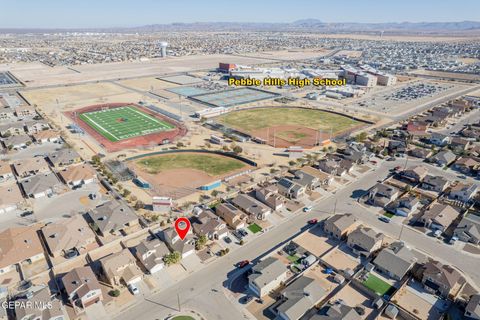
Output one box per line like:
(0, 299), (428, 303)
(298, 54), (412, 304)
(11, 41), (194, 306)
(129, 152), (249, 199)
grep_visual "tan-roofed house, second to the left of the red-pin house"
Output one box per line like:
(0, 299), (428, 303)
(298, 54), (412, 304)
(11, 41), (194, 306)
(100, 249), (143, 286)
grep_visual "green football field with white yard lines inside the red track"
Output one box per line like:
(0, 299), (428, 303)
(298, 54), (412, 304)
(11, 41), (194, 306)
(79, 106), (175, 142)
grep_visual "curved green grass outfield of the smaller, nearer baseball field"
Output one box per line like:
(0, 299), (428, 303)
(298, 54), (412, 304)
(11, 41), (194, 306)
(137, 153), (246, 176)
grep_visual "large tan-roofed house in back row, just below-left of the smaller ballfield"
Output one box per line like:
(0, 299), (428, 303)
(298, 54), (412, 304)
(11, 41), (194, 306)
(87, 201), (139, 237)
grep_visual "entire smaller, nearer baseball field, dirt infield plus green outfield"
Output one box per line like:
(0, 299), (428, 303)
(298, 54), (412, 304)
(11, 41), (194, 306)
(129, 152), (249, 199)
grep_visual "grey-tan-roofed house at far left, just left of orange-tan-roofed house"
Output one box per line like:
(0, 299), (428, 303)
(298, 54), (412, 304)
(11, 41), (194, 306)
(20, 172), (63, 199)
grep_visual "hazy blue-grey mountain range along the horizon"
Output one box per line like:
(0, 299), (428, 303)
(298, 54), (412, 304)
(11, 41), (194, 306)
(0, 19), (480, 33)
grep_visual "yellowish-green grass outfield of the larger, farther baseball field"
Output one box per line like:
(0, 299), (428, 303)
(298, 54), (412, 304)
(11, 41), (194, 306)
(217, 108), (360, 133)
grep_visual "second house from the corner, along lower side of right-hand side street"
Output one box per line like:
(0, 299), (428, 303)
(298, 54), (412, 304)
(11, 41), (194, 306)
(347, 225), (385, 257)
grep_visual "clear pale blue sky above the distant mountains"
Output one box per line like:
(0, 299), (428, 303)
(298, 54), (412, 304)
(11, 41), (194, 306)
(0, 0), (480, 28)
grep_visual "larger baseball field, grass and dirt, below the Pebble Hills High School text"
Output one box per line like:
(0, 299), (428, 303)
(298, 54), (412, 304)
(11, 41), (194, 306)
(216, 107), (364, 148)
